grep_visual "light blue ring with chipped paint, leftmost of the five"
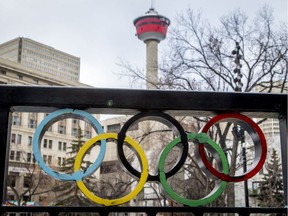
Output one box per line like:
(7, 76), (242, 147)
(33, 109), (106, 181)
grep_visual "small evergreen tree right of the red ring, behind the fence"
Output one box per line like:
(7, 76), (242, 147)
(258, 148), (284, 207)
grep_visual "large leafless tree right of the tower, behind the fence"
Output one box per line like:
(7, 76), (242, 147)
(119, 6), (288, 206)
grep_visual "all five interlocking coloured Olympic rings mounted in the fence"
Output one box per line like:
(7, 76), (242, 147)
(33, 109), (267, 206)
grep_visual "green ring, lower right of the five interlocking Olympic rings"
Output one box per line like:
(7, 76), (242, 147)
(158, 133), (229, 207)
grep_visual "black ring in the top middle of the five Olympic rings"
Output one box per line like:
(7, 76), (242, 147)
(117, 111), (189, 181)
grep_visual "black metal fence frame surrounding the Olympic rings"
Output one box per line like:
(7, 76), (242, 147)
(0, 86), (288, 215)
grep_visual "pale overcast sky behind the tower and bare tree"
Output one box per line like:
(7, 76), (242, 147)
(0, 0), (288, 88)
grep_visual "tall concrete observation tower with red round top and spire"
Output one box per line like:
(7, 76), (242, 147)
(134, 1), (170, 89)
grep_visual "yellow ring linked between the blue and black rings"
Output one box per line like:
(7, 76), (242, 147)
(74, 133), (148, 206)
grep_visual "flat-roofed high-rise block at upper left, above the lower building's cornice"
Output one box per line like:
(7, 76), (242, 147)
(0, 37), (80, 81)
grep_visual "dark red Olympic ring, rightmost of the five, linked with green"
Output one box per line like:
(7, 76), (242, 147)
(199, 113), (267, 182)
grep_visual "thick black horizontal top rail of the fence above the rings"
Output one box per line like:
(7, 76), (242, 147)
(0, 86), (287, 118)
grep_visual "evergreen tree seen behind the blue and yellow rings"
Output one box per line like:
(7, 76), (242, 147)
(55, 127), (93, 206)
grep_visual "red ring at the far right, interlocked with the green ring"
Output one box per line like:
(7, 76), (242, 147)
(199, 113), (267, 182)
